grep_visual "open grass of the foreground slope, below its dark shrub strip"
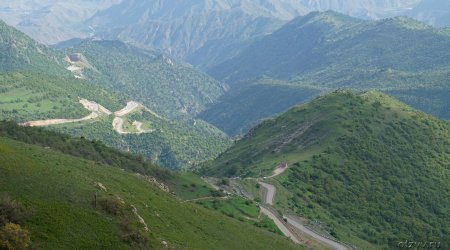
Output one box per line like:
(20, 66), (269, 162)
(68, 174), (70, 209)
(0, 137), (293, 249)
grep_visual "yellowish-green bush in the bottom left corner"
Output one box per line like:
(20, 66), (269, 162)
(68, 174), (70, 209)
(0, 223), (31, 250)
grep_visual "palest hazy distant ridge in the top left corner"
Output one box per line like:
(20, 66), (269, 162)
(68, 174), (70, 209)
(0, 0), (120, 44)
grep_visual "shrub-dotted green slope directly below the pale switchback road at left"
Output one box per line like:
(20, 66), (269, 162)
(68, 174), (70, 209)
(51, 113), (230, 170)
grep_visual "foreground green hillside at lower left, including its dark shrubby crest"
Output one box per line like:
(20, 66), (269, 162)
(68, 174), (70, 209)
(0, 123), (294, 249)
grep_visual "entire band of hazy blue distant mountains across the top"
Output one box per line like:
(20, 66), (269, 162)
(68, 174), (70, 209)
(0, 0), (449, 62)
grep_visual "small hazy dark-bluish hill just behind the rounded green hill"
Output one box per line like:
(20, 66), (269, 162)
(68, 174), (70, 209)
(198, 79), (322, 135)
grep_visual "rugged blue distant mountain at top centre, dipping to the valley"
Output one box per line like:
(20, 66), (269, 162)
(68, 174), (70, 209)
(87, 0), (418, 69)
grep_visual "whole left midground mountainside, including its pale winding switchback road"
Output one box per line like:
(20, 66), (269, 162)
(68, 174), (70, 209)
(0, 19), (230, 169)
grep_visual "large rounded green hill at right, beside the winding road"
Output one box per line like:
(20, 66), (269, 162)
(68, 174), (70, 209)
(204, 91), (450, 249)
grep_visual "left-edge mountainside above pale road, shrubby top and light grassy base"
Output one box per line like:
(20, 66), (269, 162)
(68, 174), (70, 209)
(0, 21), (126, 122)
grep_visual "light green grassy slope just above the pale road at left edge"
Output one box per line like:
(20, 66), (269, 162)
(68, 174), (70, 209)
(0, 72), (126, 122)
